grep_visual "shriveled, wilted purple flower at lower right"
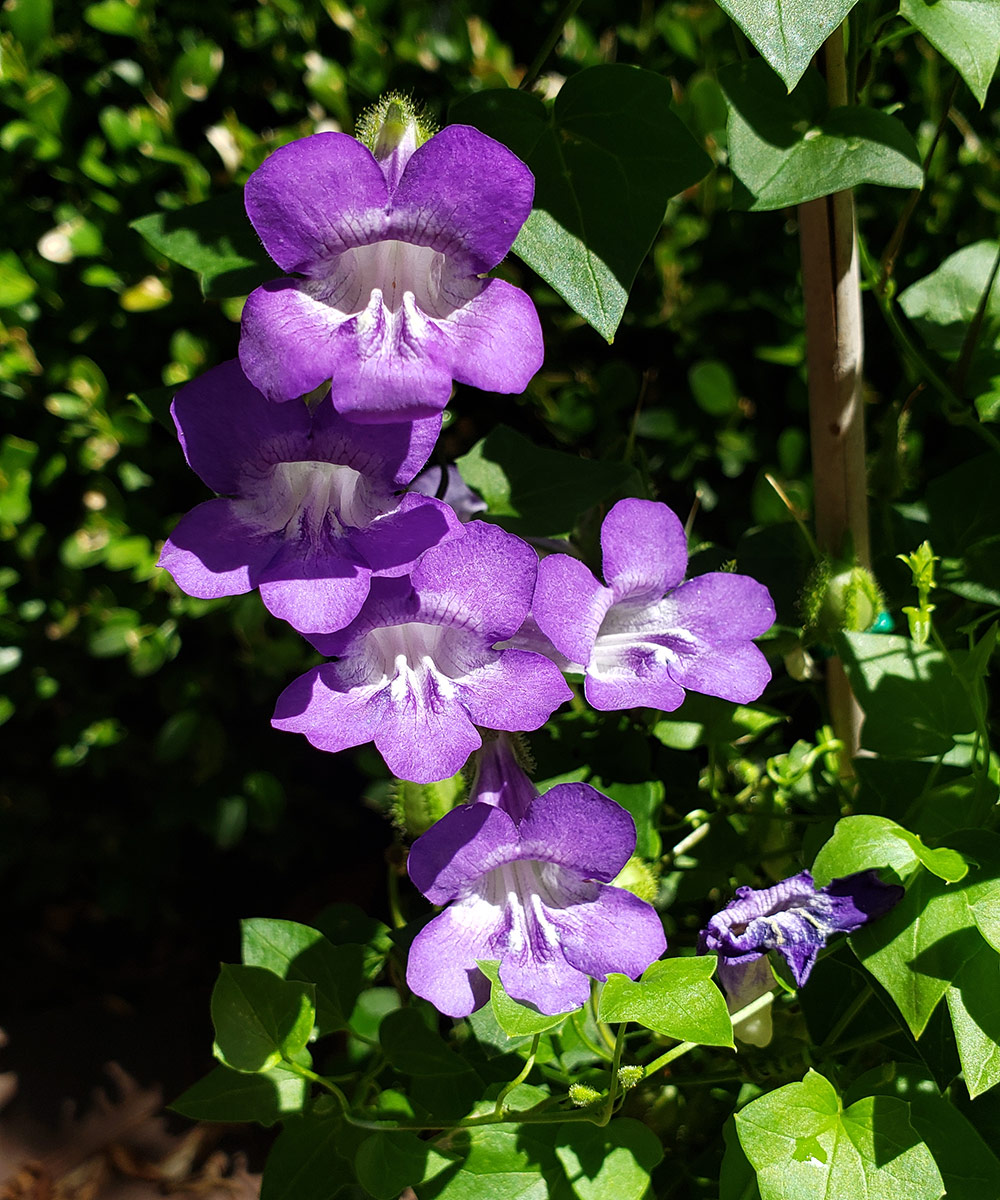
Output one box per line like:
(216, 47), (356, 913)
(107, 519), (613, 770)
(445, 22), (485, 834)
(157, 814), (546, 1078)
(697, 871), (903, 1003)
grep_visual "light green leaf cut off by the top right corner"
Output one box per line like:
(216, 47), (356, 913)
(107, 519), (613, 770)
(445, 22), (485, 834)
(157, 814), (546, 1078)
(899, 0), (1000, 107)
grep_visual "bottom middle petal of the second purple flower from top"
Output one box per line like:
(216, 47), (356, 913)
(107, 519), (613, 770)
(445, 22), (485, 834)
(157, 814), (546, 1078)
(257, 539), (371, 634)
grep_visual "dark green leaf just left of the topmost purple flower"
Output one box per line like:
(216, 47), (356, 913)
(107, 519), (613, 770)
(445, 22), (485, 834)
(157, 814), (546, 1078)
(130, 191), (280, 299)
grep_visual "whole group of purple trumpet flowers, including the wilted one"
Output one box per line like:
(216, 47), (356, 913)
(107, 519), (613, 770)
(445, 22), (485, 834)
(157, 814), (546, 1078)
(160, 97), (897, 1016)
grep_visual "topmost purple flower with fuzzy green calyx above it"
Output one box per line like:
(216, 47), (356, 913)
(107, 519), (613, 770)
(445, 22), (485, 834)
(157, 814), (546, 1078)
(240, 101), (543, 422)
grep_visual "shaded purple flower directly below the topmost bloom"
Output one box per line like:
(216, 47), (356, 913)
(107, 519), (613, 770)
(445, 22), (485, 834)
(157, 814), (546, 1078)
(160, 360), (462, 634)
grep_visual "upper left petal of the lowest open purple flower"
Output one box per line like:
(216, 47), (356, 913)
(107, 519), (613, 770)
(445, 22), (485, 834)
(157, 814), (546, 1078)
(407, 804), (520, 904)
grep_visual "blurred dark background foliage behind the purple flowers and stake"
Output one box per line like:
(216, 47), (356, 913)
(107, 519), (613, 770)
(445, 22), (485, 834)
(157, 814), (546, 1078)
(0, 0), (1000, 1104)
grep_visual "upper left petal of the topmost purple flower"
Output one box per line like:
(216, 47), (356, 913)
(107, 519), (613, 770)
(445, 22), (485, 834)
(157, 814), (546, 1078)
(245, 133), (389, 273)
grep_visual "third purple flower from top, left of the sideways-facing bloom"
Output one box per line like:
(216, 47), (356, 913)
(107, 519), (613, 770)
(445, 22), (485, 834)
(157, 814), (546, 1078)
(273, 521), (571, 784)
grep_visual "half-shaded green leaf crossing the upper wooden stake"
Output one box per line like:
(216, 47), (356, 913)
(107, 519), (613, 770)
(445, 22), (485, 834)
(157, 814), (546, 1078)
(720, 60), (923, 212)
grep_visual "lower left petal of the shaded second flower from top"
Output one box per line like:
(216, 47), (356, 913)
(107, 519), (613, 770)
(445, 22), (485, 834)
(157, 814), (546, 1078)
(156, 499), (281, 600)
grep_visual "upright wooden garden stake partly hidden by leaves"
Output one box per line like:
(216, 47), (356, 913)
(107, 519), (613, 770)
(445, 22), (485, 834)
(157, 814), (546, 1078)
(798, 26), (872, 775)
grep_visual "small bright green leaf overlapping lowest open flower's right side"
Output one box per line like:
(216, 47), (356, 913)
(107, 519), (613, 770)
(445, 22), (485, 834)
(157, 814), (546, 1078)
(598, 955), (733, 1046)
